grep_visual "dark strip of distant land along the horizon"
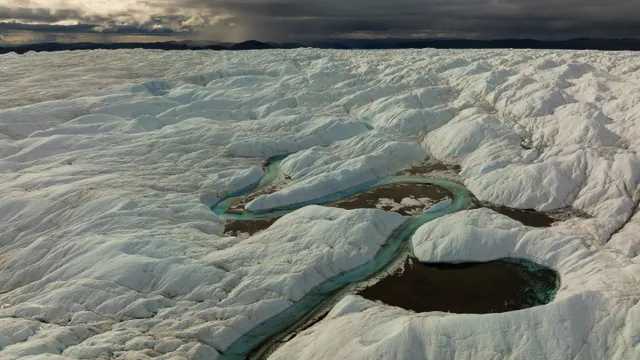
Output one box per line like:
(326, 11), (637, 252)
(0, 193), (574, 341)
(0, 38), (640, 54)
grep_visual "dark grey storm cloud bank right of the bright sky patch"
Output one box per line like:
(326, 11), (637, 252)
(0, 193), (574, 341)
(202, 0), (640, 38)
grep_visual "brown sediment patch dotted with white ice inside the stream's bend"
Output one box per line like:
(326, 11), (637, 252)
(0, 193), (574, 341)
(328, 183), (453, 215)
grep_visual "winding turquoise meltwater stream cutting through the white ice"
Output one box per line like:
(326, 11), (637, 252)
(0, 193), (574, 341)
(211, 156), (472, 360)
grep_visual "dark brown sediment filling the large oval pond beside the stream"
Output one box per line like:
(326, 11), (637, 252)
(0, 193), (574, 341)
(358, 258), (557, 314)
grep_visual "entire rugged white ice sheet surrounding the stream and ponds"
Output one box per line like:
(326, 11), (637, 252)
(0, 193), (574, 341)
(0, 49), (640, 359)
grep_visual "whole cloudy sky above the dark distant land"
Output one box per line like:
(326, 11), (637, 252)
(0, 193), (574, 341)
(0, 0), (640, 43)
